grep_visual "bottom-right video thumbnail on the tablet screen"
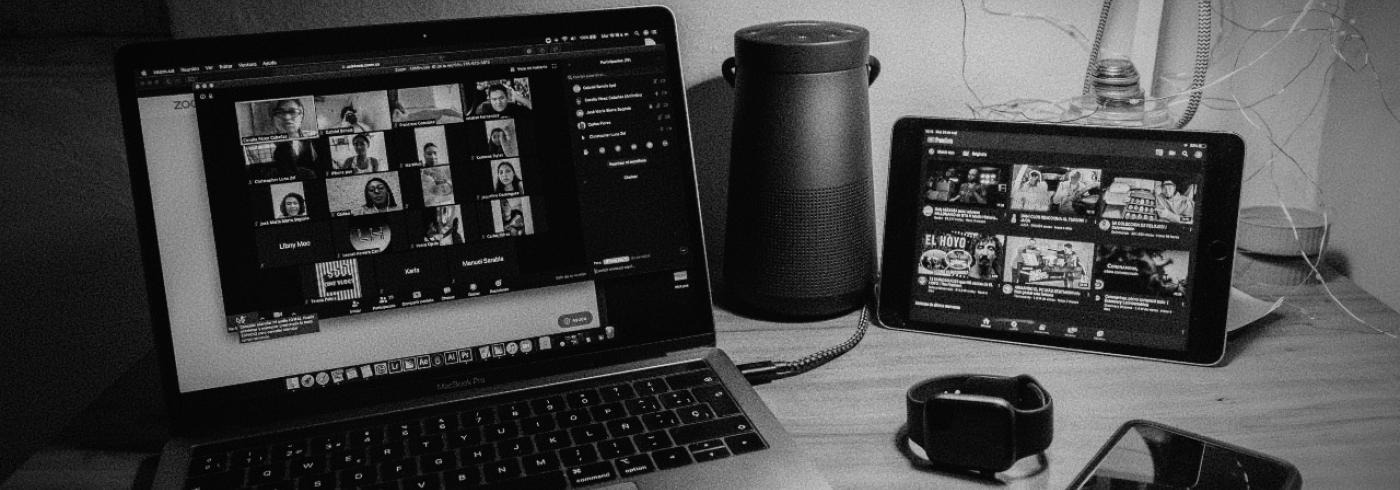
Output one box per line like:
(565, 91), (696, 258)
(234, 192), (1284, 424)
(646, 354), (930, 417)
(1095, 245), (1191, 297)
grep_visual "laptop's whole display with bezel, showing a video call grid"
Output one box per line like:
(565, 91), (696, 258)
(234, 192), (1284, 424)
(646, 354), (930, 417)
(122, 11), (713, 406)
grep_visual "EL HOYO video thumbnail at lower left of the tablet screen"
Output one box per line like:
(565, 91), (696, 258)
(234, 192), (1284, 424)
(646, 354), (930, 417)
(918, 231), (1005, 281)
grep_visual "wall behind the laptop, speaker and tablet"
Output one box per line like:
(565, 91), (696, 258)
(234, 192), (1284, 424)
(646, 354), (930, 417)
(0, 0), (1400, 479)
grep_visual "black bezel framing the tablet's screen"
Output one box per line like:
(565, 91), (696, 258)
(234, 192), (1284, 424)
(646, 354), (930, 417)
(876, 118), (1245, 365)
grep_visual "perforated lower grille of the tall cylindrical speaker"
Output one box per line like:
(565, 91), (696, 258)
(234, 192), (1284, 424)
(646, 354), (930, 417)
(725, 179), (875, 297)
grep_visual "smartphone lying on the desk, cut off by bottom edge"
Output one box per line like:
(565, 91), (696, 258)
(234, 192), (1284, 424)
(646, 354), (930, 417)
(1070, 420), (1302, 490)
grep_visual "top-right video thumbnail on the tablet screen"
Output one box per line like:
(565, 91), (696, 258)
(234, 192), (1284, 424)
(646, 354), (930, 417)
(1099, 176), (1196, 224)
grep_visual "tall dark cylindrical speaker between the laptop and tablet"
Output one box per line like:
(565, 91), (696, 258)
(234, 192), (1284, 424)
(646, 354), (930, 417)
(724, 21), (879, 319)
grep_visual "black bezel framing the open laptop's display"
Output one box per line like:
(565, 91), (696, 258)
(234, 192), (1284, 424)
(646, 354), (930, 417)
(115, 7), (715, 431)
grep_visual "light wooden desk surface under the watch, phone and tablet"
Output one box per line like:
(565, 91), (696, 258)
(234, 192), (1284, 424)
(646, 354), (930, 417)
(10, 279), (1400, 489)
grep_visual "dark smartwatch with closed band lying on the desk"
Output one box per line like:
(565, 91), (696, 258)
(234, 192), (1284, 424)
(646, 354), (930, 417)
(907, 374), (1054, 473)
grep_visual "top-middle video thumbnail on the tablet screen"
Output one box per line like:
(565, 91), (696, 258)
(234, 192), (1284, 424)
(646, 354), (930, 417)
(1011, 165), (1103, 216)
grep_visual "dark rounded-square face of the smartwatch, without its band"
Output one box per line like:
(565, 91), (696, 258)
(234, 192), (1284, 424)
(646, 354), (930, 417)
(924, 393), (1016, 472)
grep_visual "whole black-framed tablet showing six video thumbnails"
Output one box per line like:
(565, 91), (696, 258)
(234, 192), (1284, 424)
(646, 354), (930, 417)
(878, 118), (1245, 365)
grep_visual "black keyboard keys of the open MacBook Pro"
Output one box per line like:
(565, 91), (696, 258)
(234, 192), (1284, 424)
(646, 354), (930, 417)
(185, 363), (767, 490)
